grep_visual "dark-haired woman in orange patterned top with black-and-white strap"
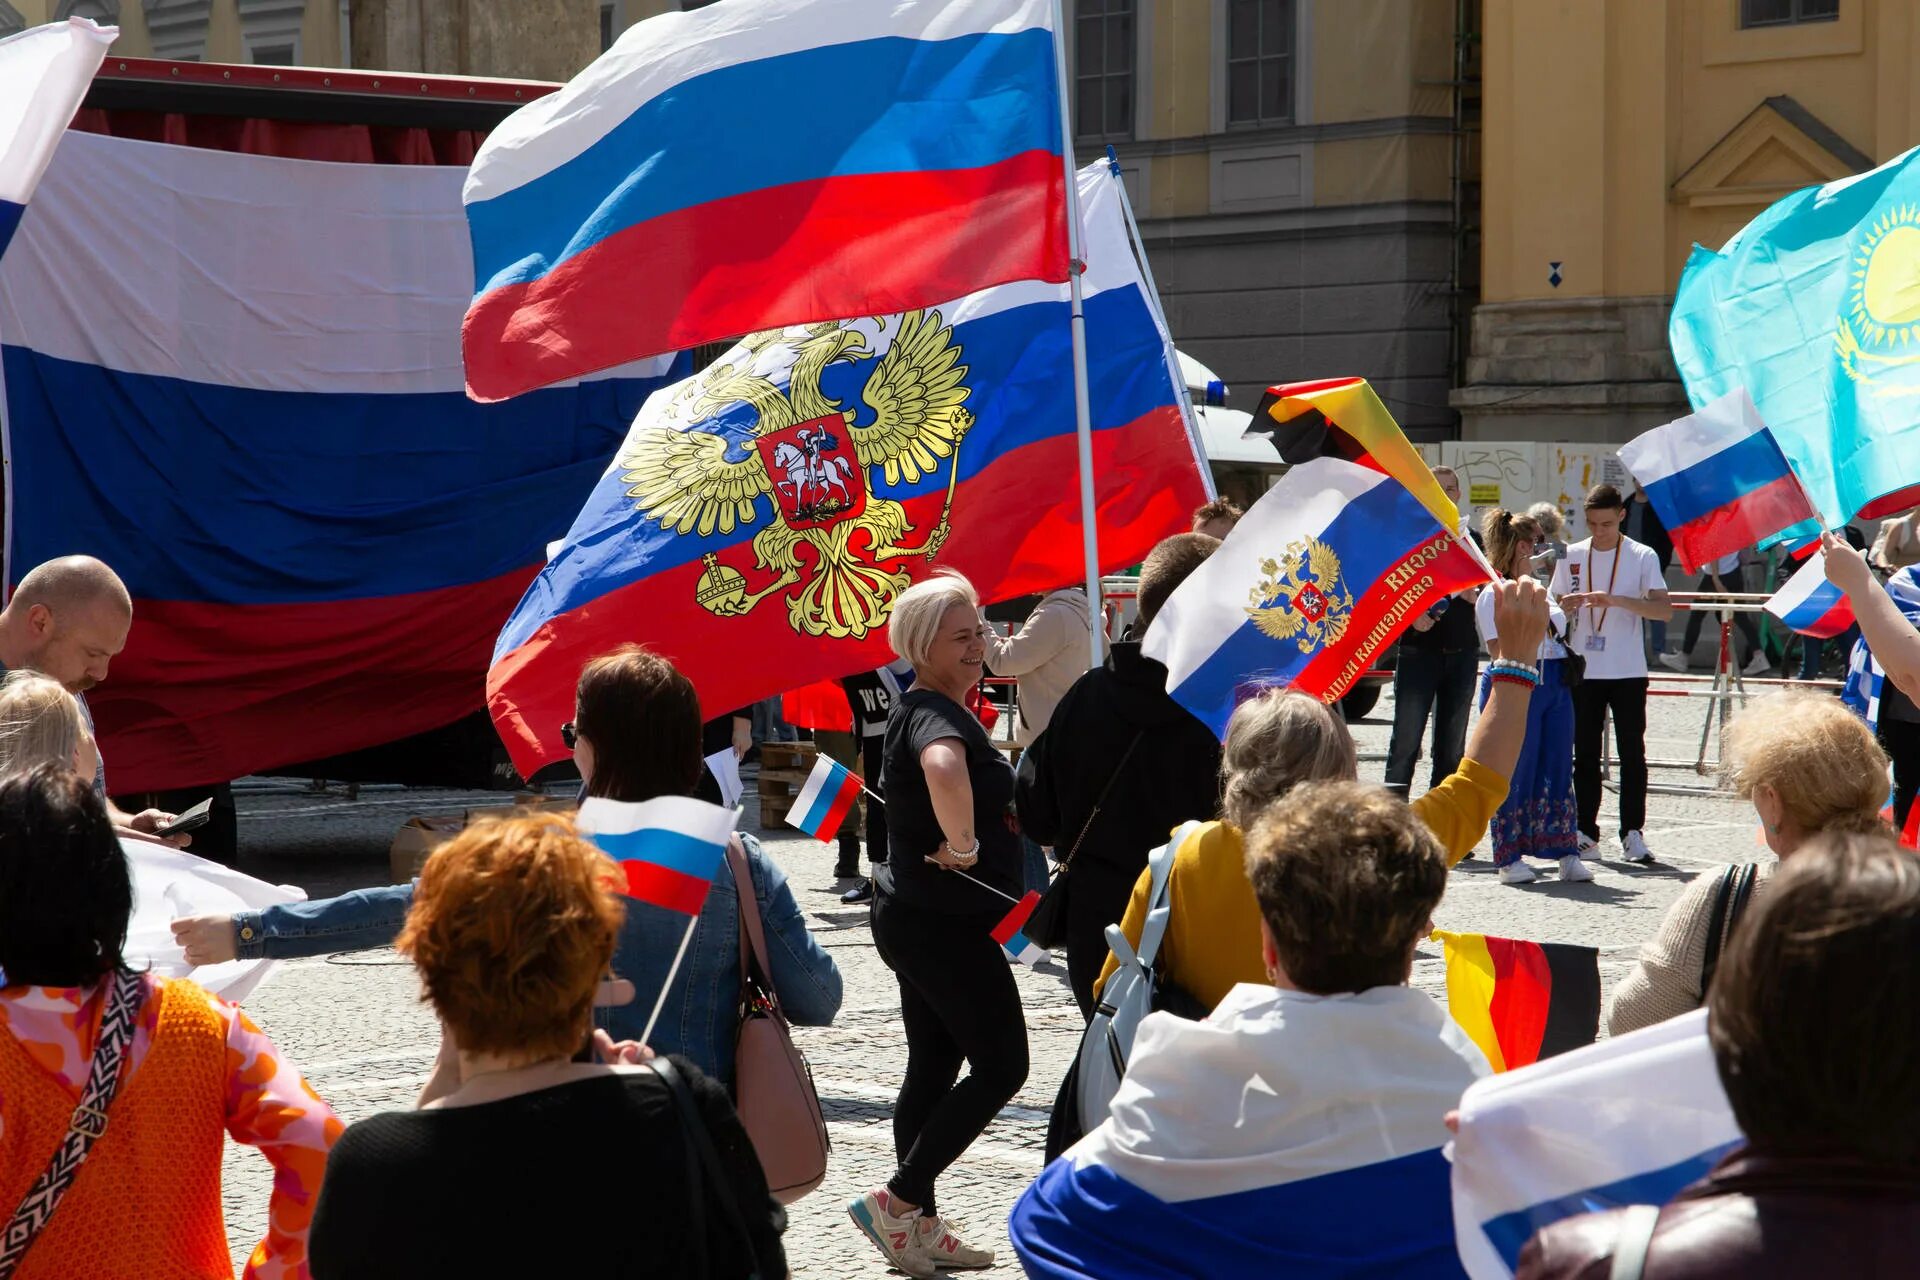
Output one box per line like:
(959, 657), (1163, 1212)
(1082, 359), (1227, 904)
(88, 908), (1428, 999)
(0, 756), (342, 1280)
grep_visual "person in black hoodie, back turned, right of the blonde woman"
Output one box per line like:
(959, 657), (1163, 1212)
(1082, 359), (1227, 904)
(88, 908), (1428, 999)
(1014, 533), (1219, 1017)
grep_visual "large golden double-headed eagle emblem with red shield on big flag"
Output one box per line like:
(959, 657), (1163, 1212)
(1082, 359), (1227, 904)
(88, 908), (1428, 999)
(620, 311), (973, 639)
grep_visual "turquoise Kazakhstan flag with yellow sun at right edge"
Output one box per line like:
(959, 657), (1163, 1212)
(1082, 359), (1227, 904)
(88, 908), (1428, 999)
(1668, 148), (1920, 537)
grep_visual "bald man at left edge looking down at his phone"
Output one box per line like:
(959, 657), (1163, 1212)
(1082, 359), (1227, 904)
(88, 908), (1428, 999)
(0, 557), (190, 848)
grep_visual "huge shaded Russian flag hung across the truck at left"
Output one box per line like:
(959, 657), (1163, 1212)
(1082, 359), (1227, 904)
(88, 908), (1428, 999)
(0, 132), (685, 791)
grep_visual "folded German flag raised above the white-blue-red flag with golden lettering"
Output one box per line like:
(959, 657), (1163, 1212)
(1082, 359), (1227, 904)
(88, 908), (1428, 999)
(1246, 378), (1459, 530)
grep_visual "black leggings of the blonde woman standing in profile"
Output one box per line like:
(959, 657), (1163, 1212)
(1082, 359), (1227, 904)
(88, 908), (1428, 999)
(874, 894), (1027, 1217)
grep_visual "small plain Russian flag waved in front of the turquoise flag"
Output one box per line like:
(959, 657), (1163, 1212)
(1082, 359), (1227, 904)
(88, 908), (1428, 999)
(1620, 390), (1814, 574)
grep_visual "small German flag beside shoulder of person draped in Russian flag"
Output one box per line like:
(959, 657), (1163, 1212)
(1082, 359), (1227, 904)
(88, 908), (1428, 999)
(1432, 929), (1599, 1071)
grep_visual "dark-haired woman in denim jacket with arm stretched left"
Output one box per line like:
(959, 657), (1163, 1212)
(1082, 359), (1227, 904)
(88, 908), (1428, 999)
(173, 645), (841, 1086)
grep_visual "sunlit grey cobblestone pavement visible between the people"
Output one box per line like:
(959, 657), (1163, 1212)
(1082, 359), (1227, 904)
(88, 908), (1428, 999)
(227, 695), (1763, 1276)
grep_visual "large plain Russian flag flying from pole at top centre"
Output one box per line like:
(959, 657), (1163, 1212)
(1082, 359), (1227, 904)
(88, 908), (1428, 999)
(465, 0), (1068, 399)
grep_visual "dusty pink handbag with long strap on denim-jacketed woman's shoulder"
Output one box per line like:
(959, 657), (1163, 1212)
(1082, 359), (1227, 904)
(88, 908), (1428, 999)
(726, 839), (833, 1205)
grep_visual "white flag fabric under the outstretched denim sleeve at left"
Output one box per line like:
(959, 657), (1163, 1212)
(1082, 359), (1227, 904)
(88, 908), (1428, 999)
(121, 839), (307, 1004)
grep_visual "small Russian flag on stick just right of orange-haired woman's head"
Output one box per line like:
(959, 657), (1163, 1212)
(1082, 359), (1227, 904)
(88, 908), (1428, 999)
(578, 796), (737, 915)
